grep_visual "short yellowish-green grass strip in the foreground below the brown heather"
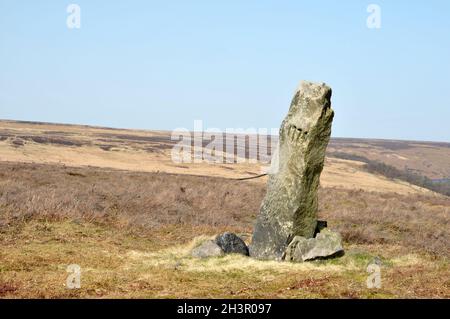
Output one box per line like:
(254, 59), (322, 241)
(0, 221), (450, 298)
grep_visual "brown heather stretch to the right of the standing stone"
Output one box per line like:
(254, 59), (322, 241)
(319, 188), (450, 257)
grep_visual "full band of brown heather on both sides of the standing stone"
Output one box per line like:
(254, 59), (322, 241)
(0, 163), (450, 256)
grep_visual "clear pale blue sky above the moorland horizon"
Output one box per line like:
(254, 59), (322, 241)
(0, 0), (450, 142)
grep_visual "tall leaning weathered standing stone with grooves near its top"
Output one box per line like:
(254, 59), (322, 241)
(250, 81), (334, 260)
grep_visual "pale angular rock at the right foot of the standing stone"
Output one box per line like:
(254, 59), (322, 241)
(284, 229), (344, 262)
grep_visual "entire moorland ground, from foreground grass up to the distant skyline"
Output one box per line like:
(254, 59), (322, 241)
(0, 121), (450, 298)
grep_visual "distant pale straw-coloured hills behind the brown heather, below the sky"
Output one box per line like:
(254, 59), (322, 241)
(0, 120), (450, 193)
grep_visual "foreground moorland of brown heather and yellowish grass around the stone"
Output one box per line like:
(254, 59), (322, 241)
(0, 163), (450, 298)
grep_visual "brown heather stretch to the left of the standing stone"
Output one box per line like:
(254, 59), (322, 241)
(0, 163), (264, 229)
